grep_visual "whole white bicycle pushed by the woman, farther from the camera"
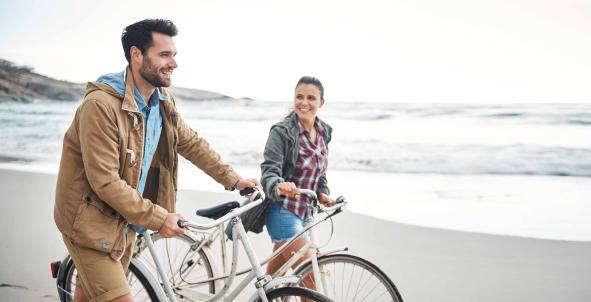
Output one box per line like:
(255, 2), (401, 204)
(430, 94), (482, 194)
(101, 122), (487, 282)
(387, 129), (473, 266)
(125, 189), (403, 302)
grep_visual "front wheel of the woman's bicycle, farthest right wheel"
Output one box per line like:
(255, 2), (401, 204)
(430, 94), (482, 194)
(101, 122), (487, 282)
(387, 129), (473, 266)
(294, 254), (402, 302)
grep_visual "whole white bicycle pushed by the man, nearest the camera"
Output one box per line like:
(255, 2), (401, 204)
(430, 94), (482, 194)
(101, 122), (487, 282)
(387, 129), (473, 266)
(51, 191), (332, 302)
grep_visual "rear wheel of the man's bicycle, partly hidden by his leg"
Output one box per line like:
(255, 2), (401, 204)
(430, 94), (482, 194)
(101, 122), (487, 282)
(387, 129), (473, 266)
(57, 256), (159, 302)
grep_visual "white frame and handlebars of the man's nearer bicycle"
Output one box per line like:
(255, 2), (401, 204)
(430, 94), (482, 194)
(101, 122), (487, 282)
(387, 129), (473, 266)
(138, 192), (300, 302)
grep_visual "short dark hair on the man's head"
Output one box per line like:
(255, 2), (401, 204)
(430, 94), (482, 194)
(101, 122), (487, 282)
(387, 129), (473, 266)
(121, 19), (178, 63)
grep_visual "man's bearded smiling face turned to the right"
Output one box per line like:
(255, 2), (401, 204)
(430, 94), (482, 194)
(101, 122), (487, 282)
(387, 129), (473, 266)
(139, 32), (177, 87)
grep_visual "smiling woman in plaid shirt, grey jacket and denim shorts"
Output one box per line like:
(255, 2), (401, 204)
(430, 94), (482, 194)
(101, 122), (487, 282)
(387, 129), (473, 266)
(261, 77), (335, 283)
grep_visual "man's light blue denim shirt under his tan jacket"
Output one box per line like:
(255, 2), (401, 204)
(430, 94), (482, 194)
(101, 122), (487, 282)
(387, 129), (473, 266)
(97, 72), (167, 233)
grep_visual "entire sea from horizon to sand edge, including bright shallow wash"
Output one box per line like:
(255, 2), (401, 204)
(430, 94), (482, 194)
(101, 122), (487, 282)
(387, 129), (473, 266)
(0, 100), (591, 241)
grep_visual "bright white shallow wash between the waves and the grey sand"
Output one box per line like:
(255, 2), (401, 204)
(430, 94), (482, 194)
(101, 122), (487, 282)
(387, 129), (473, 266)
(0, 161), (591, 242)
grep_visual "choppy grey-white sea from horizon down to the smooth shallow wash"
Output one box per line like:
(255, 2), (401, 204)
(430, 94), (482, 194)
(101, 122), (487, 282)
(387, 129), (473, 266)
(0, 102), (591, 177)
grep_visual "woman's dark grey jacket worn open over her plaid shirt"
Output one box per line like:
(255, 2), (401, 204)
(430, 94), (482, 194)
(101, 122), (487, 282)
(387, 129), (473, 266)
(261, 113), (332, 201)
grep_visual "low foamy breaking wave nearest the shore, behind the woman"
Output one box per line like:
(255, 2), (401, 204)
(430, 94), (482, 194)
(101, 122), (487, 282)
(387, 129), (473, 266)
(223, 141), (591, 177)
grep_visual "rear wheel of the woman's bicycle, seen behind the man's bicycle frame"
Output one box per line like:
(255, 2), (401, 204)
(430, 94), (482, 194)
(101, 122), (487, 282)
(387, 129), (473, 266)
(134, 233), (216, 301)
